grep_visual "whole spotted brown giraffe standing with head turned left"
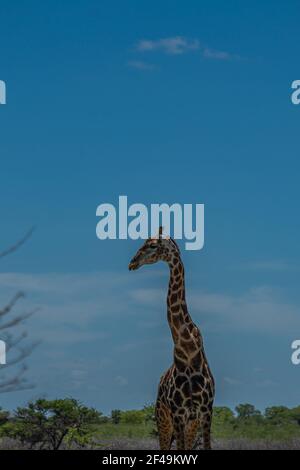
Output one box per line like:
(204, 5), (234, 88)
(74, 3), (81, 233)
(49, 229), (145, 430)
(129, 227), (215, 450)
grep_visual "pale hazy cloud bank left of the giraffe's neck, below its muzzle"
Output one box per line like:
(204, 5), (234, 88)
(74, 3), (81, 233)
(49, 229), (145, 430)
(0, 270), (165, 347)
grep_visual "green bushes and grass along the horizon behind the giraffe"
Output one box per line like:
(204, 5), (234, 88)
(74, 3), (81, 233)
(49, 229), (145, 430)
(0, 398), (300, 450)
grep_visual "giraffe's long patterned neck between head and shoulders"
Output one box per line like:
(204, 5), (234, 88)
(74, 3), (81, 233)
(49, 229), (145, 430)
(167, 255), (203, 370)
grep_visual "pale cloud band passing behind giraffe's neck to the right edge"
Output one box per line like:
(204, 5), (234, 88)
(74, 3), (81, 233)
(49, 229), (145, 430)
(130, 286), (300, 333)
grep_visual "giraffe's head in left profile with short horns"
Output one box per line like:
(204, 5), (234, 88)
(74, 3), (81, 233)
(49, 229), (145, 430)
(129, 227), (180, 271)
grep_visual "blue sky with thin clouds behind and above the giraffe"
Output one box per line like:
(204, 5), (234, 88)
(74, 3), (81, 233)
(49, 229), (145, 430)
(0, 0), (300, 412)
